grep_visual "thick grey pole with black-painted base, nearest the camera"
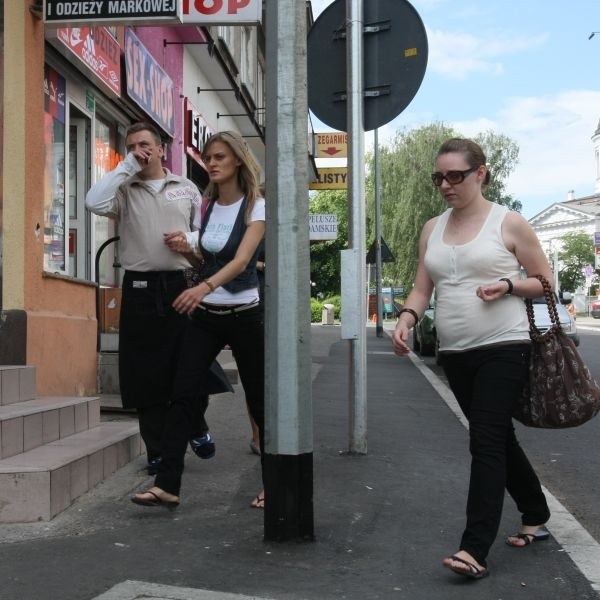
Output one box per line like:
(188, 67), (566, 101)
(262, 0), (314, 541)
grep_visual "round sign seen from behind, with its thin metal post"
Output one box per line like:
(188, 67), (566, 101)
(307, 0), (428, 454)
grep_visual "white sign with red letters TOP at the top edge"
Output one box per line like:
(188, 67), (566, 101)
(181, 0), (262, 25)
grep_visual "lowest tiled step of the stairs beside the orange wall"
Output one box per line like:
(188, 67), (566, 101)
(0, 421), (142, 523)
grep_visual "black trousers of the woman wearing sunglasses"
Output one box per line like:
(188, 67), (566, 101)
(442, 344), (550, 565)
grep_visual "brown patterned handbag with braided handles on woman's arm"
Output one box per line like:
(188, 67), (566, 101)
(513, 275), (600, 429)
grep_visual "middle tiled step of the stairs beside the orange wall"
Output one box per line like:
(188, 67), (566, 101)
(0, 397), (100, 459)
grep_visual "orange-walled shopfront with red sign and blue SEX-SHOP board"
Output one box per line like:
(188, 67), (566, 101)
(0, 7), (182, 395)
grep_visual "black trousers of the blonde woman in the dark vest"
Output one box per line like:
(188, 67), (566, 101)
(155, 304), (265, 495)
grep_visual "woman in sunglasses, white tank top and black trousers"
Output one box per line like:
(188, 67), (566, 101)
(392, 138), (553, 579)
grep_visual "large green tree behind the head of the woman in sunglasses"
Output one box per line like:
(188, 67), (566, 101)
(366, 123), (521, 291)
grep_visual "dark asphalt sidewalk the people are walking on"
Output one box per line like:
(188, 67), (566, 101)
(0, 326), (598, 600)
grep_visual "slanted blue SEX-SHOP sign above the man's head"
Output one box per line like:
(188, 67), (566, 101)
(125, 29), (175, 136)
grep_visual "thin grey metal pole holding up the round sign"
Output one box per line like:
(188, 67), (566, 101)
(346, 0), (367, 454)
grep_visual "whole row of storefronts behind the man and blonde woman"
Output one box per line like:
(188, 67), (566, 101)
(0, 2), (264, 395)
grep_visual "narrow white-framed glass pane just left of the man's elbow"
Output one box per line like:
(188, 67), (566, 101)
(68, 105), (92, 280)
